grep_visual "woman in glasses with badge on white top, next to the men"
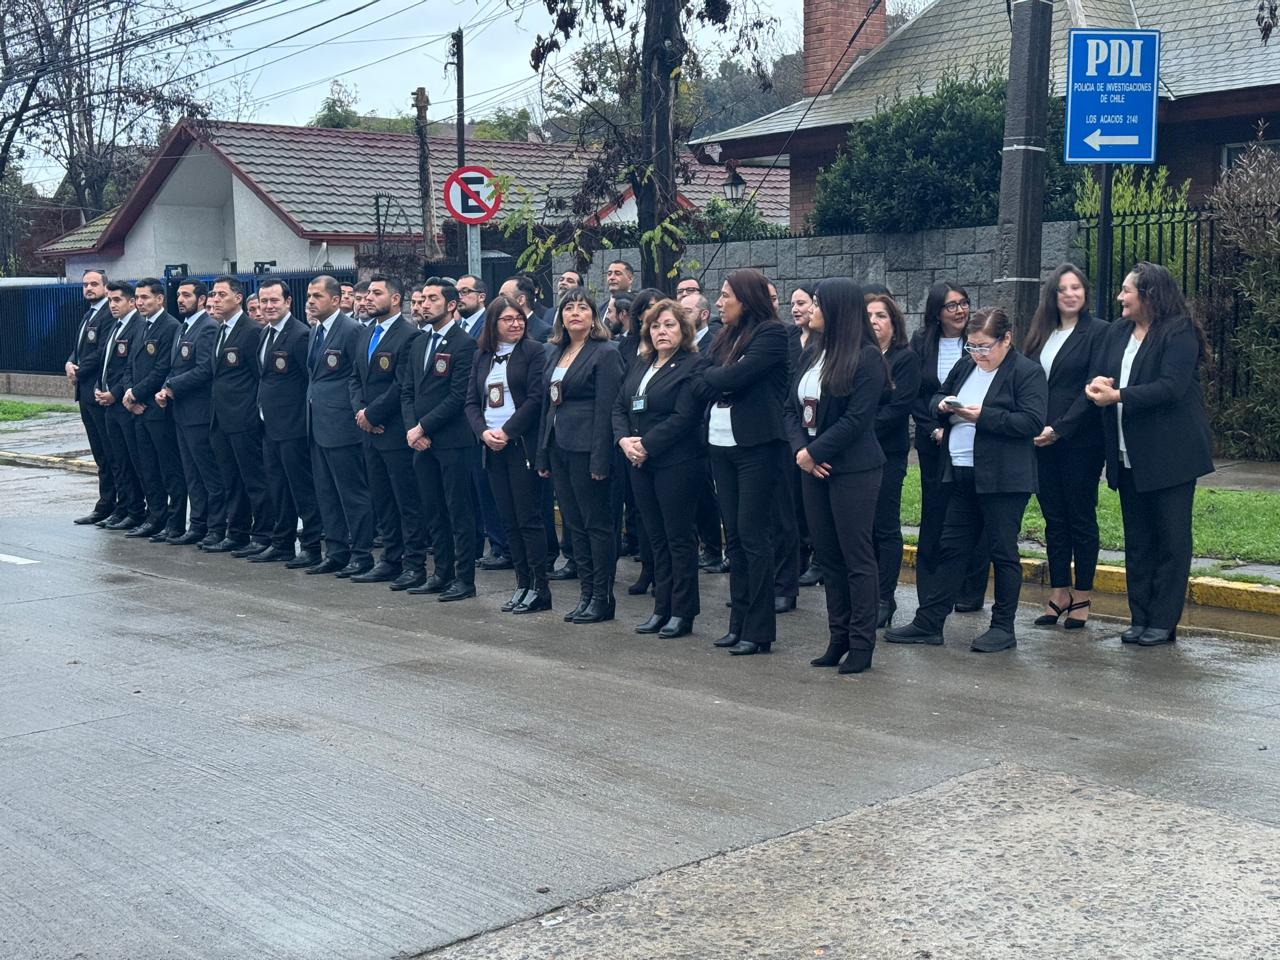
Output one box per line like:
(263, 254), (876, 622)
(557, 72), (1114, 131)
(466, 297), (552, 613)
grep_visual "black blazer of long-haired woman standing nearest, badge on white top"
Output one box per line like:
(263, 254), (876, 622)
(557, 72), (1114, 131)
(786, 343), (886, 474)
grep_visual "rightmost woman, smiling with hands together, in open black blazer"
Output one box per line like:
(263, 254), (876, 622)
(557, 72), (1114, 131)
(1085, 262), (1213, 646)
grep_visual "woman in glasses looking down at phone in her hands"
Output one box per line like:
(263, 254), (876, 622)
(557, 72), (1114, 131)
(884, 310), (1048, 653)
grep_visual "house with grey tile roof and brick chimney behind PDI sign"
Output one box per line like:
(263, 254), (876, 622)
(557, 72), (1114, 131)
(691, 0), (1280, 229)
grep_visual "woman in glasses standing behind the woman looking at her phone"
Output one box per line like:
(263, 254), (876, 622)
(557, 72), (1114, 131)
(910, 280), (991, 613)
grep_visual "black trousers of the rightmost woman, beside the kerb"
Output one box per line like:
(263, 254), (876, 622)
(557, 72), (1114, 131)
(1120, 468), (1196, 630)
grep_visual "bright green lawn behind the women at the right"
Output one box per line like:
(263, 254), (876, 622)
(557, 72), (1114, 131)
(902, 466), (1280, 563)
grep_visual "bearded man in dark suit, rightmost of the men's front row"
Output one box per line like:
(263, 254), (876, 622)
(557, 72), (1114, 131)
(397, 276), (479, 600)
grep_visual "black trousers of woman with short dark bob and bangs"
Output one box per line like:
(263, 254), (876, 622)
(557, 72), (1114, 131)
(548, 445), (618, 596)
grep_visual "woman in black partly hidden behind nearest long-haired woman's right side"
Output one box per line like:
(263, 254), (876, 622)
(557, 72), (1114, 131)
(867, 293), (920, 630)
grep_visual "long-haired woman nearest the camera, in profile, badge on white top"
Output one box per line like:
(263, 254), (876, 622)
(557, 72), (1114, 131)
(786, 276), (888, 673)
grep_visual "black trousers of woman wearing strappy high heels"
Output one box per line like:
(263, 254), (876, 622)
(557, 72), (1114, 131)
(1036, 443), (1105, 590)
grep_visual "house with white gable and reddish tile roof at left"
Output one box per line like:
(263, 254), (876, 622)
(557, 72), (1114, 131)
(37, 120), (787, 276)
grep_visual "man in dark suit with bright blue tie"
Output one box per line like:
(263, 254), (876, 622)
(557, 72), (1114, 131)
(351, 274), (426, 590)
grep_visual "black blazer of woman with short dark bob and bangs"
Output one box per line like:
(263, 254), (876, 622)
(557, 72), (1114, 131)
(538, 337), (622, 476)
